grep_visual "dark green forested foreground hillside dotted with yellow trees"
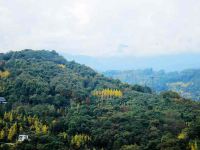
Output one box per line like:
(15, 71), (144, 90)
(0, 50), (200, 150)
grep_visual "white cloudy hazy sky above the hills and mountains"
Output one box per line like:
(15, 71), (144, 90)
(0, 0), (200, 56)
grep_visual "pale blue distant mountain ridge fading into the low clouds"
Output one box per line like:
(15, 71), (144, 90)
(61, 53), (200, 72)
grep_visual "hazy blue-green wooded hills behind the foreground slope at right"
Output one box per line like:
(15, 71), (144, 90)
(104, 69), (200, 100)
